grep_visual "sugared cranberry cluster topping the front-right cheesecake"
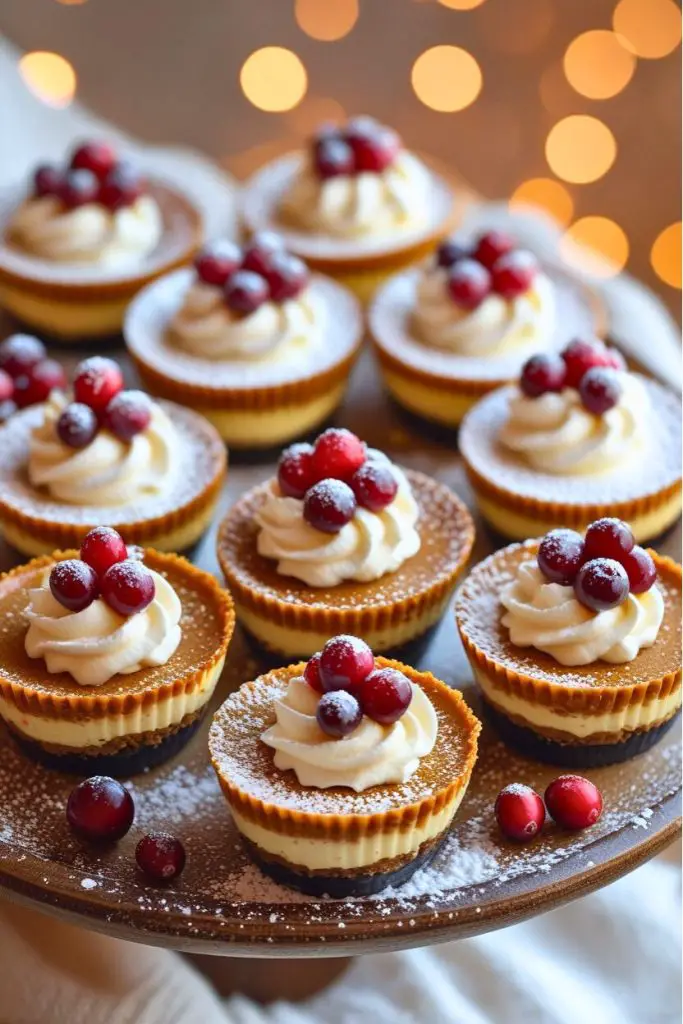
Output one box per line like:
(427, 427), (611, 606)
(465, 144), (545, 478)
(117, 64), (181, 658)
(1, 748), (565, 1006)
(537, 518), (656, 611)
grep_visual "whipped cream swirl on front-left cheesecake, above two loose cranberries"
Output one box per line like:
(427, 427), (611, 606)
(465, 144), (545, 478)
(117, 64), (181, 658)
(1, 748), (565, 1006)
(25, 569), (181, 686)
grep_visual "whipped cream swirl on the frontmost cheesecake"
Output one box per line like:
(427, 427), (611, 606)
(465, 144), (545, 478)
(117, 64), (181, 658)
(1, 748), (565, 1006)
(261, 676), (438, 793)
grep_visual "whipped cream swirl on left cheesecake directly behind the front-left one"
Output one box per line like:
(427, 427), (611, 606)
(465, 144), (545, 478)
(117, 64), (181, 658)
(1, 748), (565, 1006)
(29, 391), (178, 505)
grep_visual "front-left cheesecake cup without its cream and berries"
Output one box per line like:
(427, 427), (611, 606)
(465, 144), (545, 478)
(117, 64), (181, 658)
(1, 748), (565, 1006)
(0, 549), (234, 775)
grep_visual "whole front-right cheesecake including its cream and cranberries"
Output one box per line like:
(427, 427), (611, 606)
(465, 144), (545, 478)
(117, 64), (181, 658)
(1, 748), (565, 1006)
(456, 518), (681, 768)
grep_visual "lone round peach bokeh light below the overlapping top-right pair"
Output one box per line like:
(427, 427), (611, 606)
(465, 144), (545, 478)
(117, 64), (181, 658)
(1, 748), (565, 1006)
(546, 114), (616, 184)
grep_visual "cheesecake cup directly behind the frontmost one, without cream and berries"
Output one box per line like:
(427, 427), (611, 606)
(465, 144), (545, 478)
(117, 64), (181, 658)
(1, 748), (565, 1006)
(218, 470), (474, 657)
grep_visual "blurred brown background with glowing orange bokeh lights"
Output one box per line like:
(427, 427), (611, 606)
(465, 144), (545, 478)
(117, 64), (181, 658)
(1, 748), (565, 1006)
(0, 0), (681, 318)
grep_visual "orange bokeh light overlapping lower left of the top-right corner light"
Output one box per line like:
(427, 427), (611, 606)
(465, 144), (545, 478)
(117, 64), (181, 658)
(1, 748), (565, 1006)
(564, 30), (636, 99)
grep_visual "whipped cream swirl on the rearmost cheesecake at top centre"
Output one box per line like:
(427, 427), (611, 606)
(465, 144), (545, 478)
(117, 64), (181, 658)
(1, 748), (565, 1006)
(283, 150), (430, 239)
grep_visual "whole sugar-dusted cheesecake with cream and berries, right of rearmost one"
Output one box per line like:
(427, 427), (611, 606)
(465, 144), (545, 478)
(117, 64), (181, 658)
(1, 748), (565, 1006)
(369, 231), (606, 428)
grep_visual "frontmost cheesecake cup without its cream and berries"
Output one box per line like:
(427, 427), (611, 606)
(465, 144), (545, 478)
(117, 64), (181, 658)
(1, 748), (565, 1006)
(209, 657), (480, 898)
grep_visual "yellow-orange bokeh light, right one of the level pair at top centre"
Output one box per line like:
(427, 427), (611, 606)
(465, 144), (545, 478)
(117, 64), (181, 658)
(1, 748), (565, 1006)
(411, 46), (481, 113)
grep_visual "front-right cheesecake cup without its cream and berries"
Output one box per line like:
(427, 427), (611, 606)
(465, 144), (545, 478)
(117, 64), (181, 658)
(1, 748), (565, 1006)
(456, 541), (681, 768)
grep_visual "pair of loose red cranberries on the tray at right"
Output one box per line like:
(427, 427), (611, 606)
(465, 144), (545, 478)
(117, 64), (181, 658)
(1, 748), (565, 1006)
(495, 775), (602, 843)
